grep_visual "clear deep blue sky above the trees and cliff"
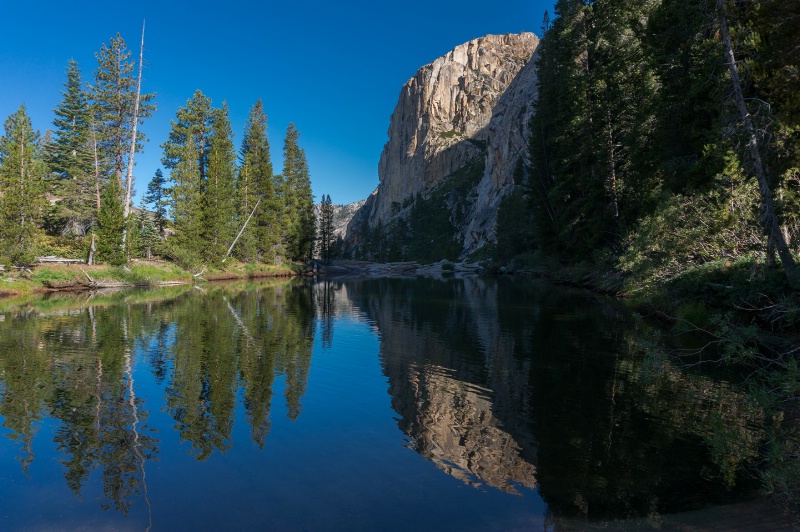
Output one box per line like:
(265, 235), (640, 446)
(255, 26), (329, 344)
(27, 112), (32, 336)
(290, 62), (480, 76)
(0, 0), (553, 203)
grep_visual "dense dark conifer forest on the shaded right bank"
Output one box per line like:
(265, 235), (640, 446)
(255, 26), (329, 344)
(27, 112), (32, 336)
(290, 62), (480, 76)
(512, 0), (800, 287)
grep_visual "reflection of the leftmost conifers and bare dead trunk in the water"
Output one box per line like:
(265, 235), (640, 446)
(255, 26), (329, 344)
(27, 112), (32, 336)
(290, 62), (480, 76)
(0, 306), (158, 511)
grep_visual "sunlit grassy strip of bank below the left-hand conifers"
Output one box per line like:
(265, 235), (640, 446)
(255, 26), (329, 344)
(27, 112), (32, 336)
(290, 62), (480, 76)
(0, 260), (307, 297)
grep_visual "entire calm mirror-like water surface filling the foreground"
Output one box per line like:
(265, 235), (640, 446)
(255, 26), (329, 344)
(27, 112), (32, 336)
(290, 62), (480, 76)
(0, 279), (776, 530)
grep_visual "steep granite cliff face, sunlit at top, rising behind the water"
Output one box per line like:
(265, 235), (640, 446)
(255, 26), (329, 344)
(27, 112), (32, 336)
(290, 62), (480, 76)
(348, 33), (539, 253)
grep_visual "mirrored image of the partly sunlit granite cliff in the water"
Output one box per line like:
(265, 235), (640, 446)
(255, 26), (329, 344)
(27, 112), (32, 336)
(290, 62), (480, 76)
(348, 279), (536, 493)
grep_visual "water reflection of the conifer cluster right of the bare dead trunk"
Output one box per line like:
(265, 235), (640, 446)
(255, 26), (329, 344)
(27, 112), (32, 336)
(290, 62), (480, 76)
(161, 284), (314, 460)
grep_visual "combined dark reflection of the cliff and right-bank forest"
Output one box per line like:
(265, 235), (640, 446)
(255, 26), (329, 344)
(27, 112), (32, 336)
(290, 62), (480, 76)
(347, 278), (763, 528)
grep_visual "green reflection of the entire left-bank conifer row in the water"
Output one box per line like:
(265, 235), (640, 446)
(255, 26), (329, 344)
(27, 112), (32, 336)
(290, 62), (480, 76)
(0, 285), (315, 512)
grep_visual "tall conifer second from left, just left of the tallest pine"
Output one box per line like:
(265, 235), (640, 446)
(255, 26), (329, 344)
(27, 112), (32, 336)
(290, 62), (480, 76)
(45, 60), (97, 236)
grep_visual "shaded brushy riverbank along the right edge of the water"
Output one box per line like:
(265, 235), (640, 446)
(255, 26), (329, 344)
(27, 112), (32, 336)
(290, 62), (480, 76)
(507, 253), (800, 512)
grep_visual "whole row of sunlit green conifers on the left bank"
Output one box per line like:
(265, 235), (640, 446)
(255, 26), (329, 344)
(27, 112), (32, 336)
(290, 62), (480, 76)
(0, 35), (316, 268)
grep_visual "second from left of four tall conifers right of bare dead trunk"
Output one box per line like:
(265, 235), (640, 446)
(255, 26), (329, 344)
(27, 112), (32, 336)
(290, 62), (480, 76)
(203, 103), (237, 262)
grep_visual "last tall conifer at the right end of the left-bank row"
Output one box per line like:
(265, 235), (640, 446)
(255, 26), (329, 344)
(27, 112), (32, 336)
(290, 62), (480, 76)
(283, 124), (316, 261)
